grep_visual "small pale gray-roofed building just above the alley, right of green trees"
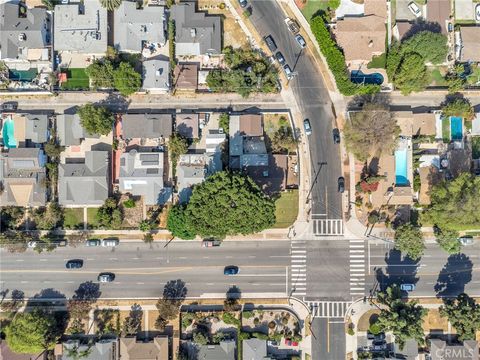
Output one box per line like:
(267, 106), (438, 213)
(142, 56), (170, 92)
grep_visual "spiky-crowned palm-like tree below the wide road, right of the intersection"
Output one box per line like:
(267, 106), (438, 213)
(375, 286), (427, 349)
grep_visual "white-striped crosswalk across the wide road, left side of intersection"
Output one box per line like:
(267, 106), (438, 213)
(290, 240), (307, 297)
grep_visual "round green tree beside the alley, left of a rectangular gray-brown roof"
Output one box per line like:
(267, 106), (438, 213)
(78, 103), (114, 135)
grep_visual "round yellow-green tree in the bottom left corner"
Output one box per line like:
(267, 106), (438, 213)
(5, 310), (57, 354)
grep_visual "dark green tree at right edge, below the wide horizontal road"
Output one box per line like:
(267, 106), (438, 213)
(440, 294), (480, 341)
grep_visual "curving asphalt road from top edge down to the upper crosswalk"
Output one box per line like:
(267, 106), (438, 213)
(250, 0), (342, 219)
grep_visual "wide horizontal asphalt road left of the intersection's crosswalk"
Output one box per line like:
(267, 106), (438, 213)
(0, 241), (290, 298)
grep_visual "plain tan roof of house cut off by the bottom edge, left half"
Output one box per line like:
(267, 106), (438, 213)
(120, 336), (169, 360)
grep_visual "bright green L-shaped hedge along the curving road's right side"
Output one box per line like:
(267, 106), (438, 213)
(310, 15), (380, 96)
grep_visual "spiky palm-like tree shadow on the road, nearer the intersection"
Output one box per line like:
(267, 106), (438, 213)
(372, 249), (419, 295)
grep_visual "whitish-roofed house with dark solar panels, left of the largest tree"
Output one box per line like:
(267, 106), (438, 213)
(119, 150), (171, 205)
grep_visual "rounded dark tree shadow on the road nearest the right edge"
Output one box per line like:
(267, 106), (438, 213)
(434, 254), (473, 298)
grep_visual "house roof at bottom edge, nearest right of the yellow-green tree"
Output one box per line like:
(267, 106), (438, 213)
(54, 339), (119, 360)
